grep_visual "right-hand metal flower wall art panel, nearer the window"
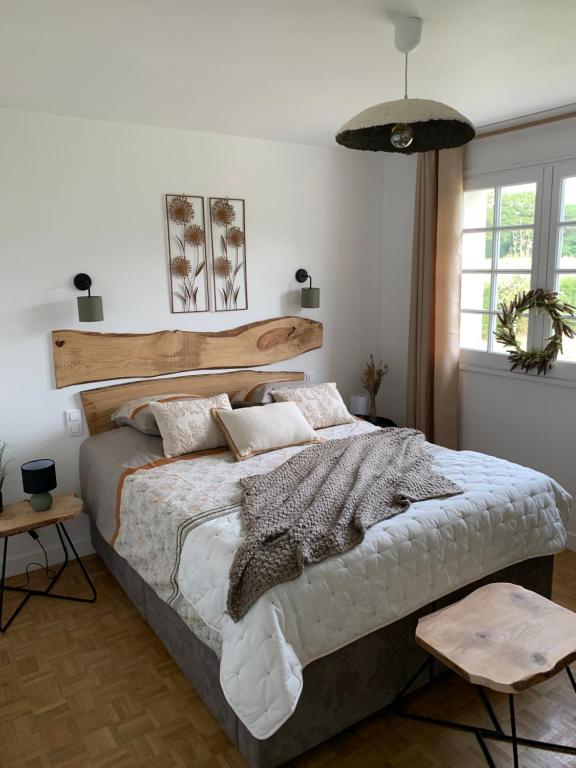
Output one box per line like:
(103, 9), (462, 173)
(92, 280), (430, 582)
(210, 197), (248, 312)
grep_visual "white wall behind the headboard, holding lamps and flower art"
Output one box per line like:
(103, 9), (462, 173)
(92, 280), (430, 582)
(0, 110), (388, 572)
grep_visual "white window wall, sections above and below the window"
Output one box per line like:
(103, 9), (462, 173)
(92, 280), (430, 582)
(460, 120), (576, 550)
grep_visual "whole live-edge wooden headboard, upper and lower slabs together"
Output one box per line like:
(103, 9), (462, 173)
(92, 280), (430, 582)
(52, 317), (323, 435)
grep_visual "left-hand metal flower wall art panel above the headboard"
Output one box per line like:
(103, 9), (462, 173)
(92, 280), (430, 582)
(166, 195), (210, 312)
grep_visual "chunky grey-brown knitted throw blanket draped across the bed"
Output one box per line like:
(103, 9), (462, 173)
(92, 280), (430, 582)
(228, 429), (462, 621)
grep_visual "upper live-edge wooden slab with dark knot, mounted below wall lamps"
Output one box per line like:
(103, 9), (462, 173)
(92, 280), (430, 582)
(52, 317), (323, 388)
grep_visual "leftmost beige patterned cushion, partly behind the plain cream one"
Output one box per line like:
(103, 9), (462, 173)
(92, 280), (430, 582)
(150, 395), (232, 458)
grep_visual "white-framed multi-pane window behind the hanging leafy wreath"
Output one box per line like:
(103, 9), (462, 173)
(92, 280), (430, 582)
(460, 162), (576, 376)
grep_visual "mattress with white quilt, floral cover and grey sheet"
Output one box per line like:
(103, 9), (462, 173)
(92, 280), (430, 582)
(81, 422), (571, 739)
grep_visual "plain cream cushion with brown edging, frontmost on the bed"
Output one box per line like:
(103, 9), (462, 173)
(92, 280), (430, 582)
(212, 403), (323, 461)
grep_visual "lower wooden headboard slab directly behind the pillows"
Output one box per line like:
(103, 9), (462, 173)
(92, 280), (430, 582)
(80, 371), (304, 435)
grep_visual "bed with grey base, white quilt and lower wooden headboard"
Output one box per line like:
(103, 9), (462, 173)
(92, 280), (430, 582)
(56, 318), (570, 768)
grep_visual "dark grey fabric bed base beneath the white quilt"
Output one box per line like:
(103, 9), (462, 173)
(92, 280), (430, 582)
(90, 521), (554, 768)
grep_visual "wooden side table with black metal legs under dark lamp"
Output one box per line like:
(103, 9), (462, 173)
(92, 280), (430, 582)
(0, 494), (96, 632)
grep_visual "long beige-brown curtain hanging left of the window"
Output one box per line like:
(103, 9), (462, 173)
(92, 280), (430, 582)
(407, 147), (464, 448)
